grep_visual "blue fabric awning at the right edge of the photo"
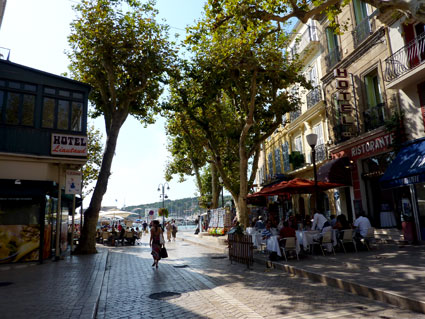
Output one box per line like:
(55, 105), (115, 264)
(380, 138), (425, 188)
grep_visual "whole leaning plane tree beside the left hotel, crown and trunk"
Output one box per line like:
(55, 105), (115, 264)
(68, 0), (175, 254)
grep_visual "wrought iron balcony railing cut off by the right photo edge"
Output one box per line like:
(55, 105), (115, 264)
(384, 33), (425, 82)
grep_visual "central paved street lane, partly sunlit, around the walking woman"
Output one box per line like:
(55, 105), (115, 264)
(97, 237), (425, 319)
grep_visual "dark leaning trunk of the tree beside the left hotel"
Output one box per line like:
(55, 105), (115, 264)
(75, 114), (127, 254)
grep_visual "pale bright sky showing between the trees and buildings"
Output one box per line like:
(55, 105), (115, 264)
(0, 0), (205, 207)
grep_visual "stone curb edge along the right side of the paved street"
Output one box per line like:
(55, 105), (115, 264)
(182, 238), (425, 313)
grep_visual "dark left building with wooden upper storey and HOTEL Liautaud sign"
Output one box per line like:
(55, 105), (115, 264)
(0, 60), (90, 262)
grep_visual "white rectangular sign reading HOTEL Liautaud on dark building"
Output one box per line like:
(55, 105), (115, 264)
(51, 133), (87, 156)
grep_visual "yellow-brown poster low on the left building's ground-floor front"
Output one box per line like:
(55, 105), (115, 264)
(0, 225), (40, 263)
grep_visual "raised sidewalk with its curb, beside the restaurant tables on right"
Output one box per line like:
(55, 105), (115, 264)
(180, 232), (425, 313)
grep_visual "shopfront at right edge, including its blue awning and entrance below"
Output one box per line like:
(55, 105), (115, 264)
(380, 138), (425, 242)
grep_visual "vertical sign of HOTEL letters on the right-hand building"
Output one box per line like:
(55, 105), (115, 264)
(334, 69), (354, 137)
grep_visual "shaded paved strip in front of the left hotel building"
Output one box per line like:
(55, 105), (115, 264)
(0, 246), (108, 319)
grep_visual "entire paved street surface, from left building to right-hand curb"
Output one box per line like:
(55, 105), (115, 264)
(0, 233), (425, 319)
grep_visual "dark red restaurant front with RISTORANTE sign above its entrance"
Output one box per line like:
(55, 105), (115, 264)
(330, 130), (401, 228)
